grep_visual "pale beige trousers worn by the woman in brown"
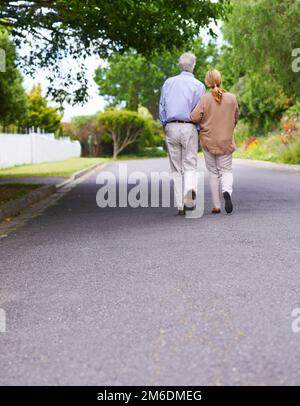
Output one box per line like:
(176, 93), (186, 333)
(204, 151), (233, 209)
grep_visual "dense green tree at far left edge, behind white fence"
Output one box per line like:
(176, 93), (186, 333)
(0, 28), (27, 127)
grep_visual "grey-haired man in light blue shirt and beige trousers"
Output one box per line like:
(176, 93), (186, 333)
(159, 53), (205, 215)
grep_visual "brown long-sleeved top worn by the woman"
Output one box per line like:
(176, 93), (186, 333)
(191, 92), (239, 155)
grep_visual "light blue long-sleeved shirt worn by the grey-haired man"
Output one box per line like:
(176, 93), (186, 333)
(159, 72), (205, 125)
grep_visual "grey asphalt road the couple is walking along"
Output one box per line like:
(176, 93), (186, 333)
(0, 159), (300, 385)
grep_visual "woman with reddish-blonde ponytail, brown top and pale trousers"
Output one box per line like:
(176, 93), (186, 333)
(191, 69), (239, 213)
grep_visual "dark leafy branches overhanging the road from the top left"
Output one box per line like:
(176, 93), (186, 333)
(0, 0), (229, 102)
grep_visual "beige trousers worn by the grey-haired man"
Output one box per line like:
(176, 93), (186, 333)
(165, 123), (198, 209)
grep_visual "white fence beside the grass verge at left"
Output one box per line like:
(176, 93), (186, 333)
(0, 133), (81, 168)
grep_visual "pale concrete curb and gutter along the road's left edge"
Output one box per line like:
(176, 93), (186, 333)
(0, 162), (107, 222)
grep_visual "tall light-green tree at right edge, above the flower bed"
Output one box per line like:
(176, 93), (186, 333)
(218, 0), (300, 134)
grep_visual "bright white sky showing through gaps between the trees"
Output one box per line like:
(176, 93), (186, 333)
(23, 25), (223, 122)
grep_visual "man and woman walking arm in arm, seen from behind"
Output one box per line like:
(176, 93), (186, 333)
(160, 53), (239, 215)
